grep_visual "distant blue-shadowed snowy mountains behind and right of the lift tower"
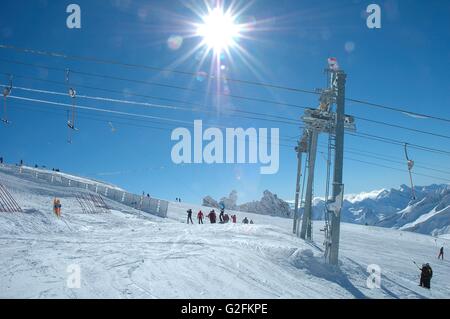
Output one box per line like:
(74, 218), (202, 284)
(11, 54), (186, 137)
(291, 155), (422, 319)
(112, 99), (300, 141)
(298, 184), (450, 236)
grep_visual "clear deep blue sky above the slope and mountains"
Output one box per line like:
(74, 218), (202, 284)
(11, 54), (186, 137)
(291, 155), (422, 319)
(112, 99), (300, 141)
(0, 0), (450, 203)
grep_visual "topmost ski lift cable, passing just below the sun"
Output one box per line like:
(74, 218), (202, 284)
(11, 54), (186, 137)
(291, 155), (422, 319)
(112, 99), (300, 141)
(0, 44), (450, 123)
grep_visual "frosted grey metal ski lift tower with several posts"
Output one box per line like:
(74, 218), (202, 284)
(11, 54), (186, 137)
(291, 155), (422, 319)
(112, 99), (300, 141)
(294, 58), (355, 265)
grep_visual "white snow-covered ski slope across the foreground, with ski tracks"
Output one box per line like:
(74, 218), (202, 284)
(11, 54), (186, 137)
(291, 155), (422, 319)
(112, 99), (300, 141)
(0, 171), (450, 298)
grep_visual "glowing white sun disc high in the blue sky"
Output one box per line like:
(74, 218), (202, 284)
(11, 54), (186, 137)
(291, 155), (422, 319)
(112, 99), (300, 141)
(197, 7), (241, 53)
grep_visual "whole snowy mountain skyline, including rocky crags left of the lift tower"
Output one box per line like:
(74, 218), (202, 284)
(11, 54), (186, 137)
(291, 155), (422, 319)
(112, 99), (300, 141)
(203, 184), (450, 236)
